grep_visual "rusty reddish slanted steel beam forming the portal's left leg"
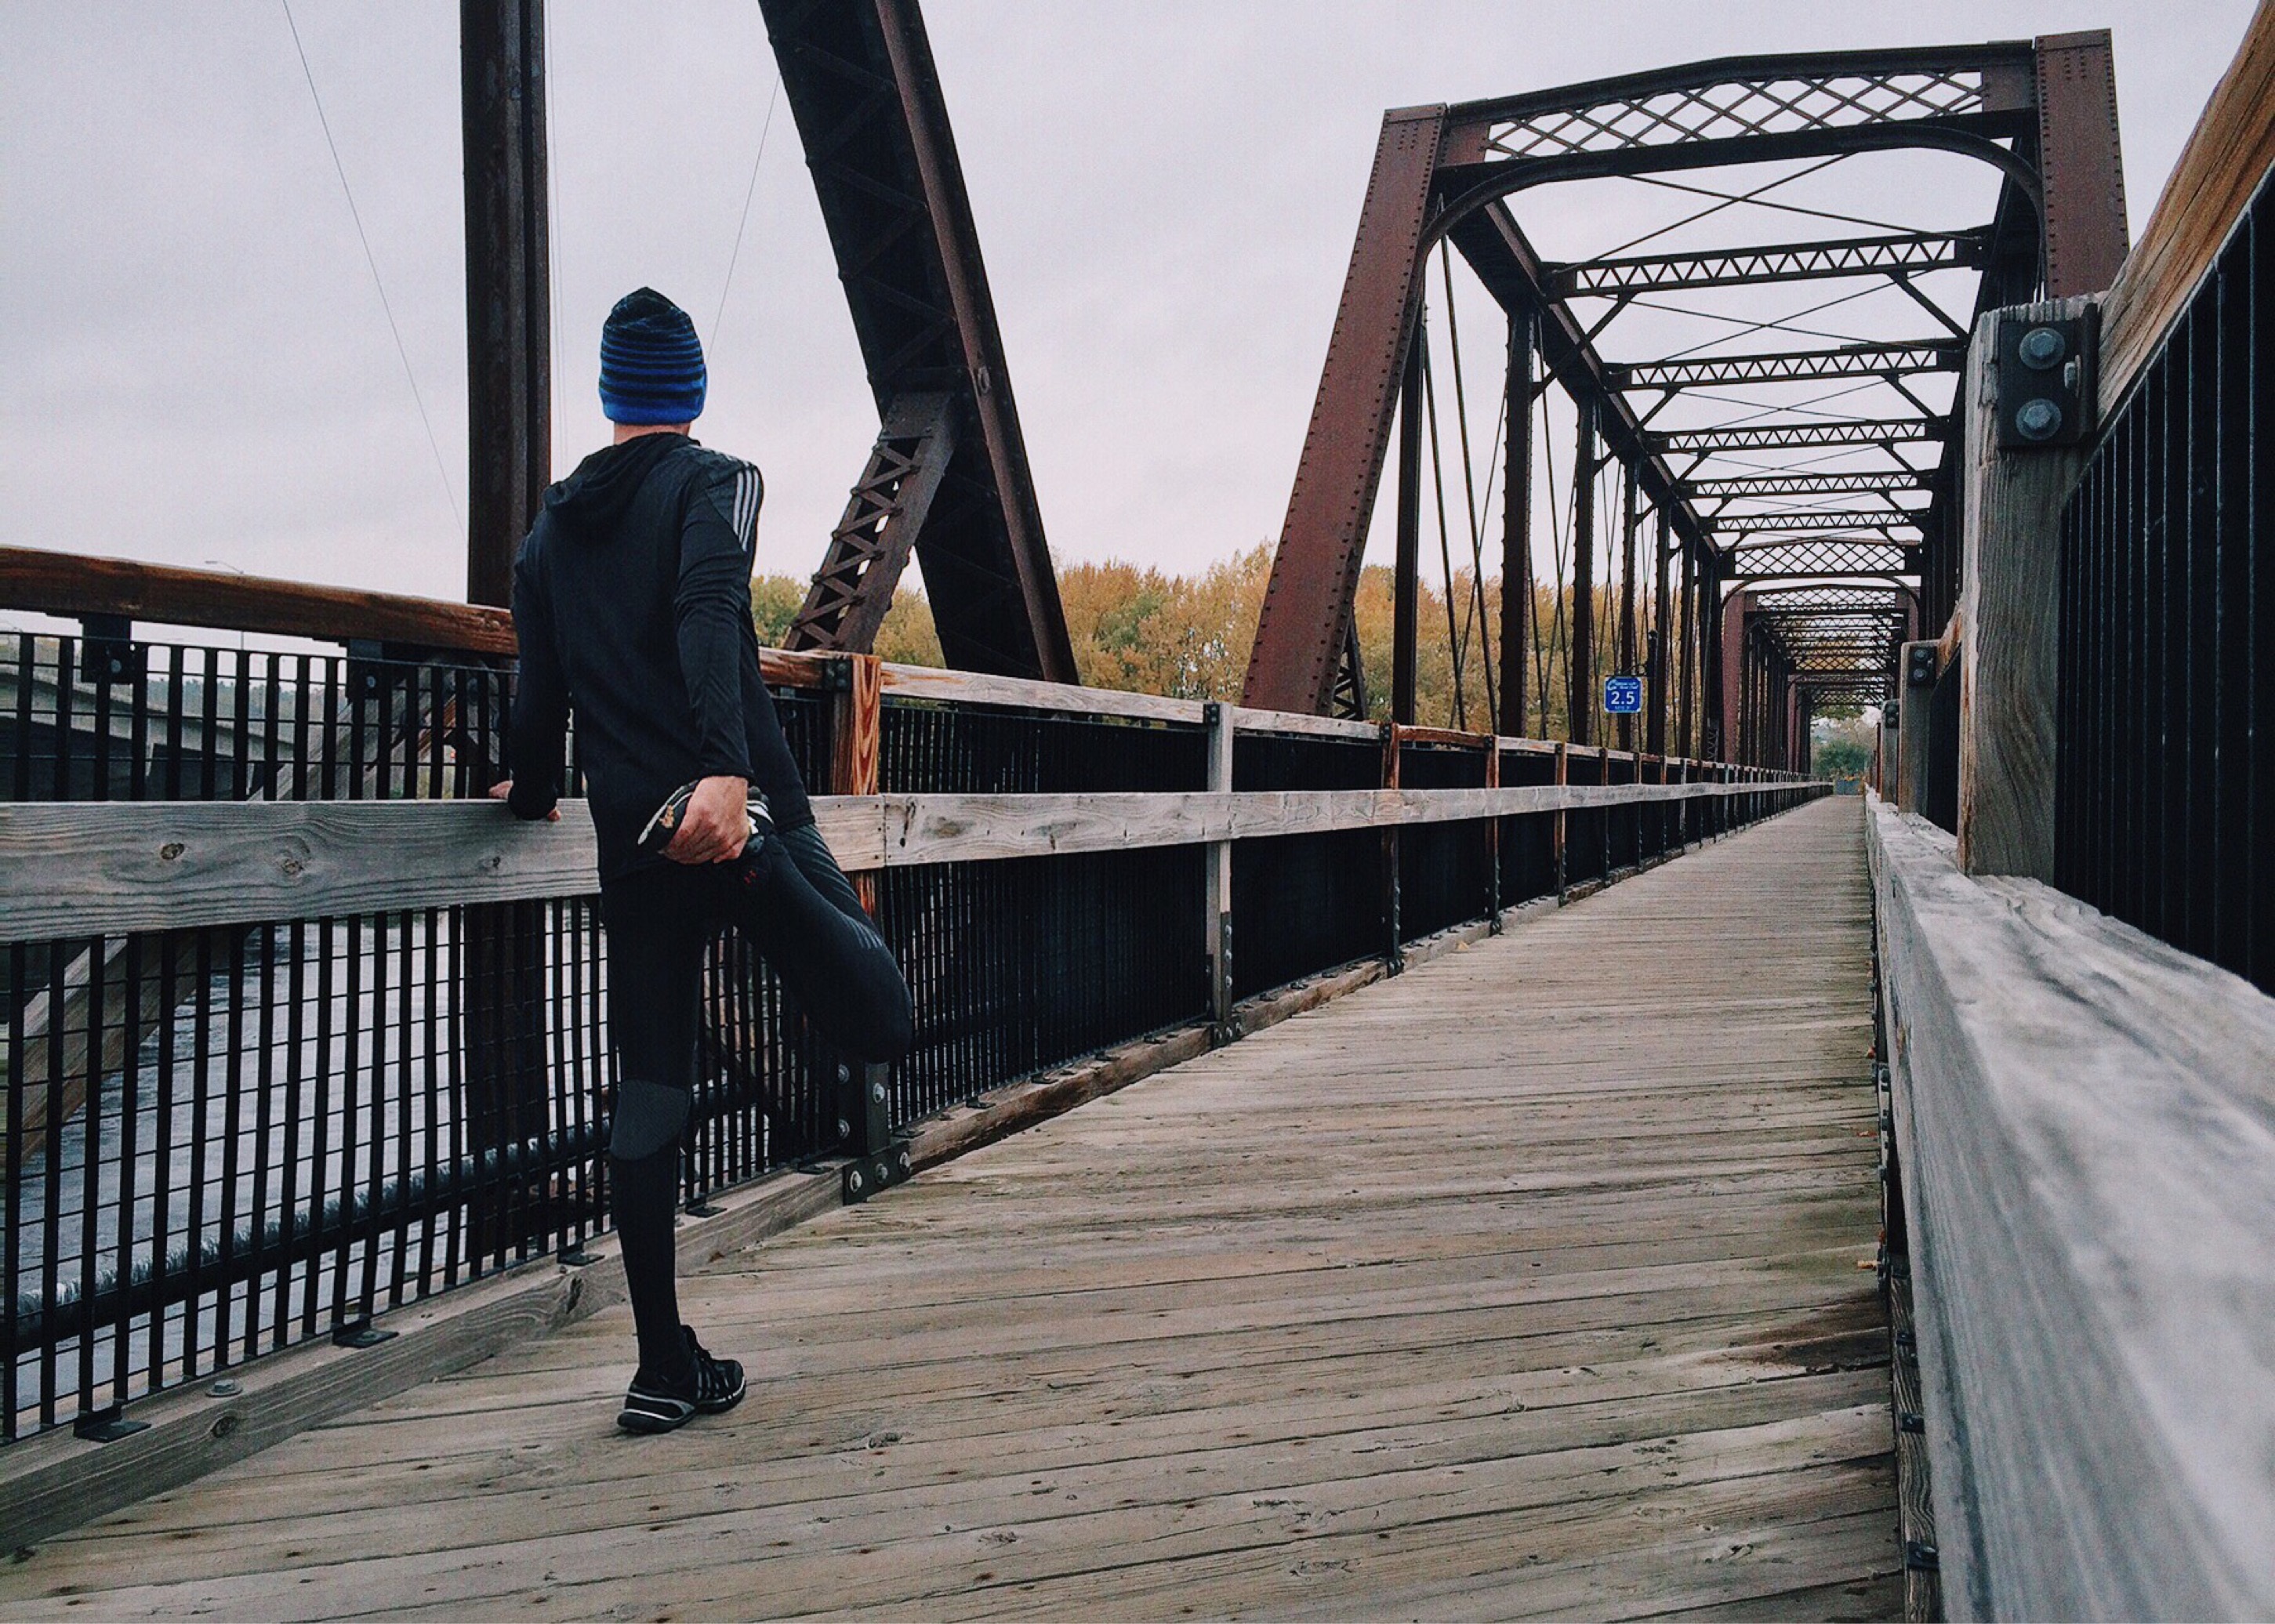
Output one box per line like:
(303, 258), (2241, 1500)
(1242, 107), (1445, 712)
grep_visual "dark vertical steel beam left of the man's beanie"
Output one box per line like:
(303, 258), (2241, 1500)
(457, 0), (553, 605)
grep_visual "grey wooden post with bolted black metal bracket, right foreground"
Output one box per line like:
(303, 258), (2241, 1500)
(1956, 298), (2098, 880)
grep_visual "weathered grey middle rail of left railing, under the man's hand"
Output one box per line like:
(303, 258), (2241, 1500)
(0, 780), (1809, 941)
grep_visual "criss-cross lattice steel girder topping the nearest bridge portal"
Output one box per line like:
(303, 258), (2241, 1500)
(1447, 41), (2036, 164)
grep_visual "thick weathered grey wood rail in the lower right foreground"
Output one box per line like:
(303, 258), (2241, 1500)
(1870, 800), (2275, 1617)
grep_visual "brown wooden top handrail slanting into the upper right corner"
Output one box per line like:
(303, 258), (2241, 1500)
(2098, 0), (2275, 423)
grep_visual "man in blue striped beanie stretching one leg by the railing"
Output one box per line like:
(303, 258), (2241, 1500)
(492, 289), (913, 1433)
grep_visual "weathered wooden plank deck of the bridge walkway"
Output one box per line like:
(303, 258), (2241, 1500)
(0, 799), (1902, 1619)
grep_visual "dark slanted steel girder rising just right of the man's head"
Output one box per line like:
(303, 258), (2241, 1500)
(760, 0), (1079, 683)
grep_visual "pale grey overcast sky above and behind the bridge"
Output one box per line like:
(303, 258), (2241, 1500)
(0, 0), (2250, 596)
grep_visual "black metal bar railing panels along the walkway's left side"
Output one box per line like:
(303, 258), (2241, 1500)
(0, 635), (1810, 1440)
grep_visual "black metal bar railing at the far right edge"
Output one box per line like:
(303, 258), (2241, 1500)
(2055, 182), (2275, 991)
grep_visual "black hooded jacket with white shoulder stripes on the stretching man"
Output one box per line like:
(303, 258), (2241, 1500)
(510, 434), (815, 880)
